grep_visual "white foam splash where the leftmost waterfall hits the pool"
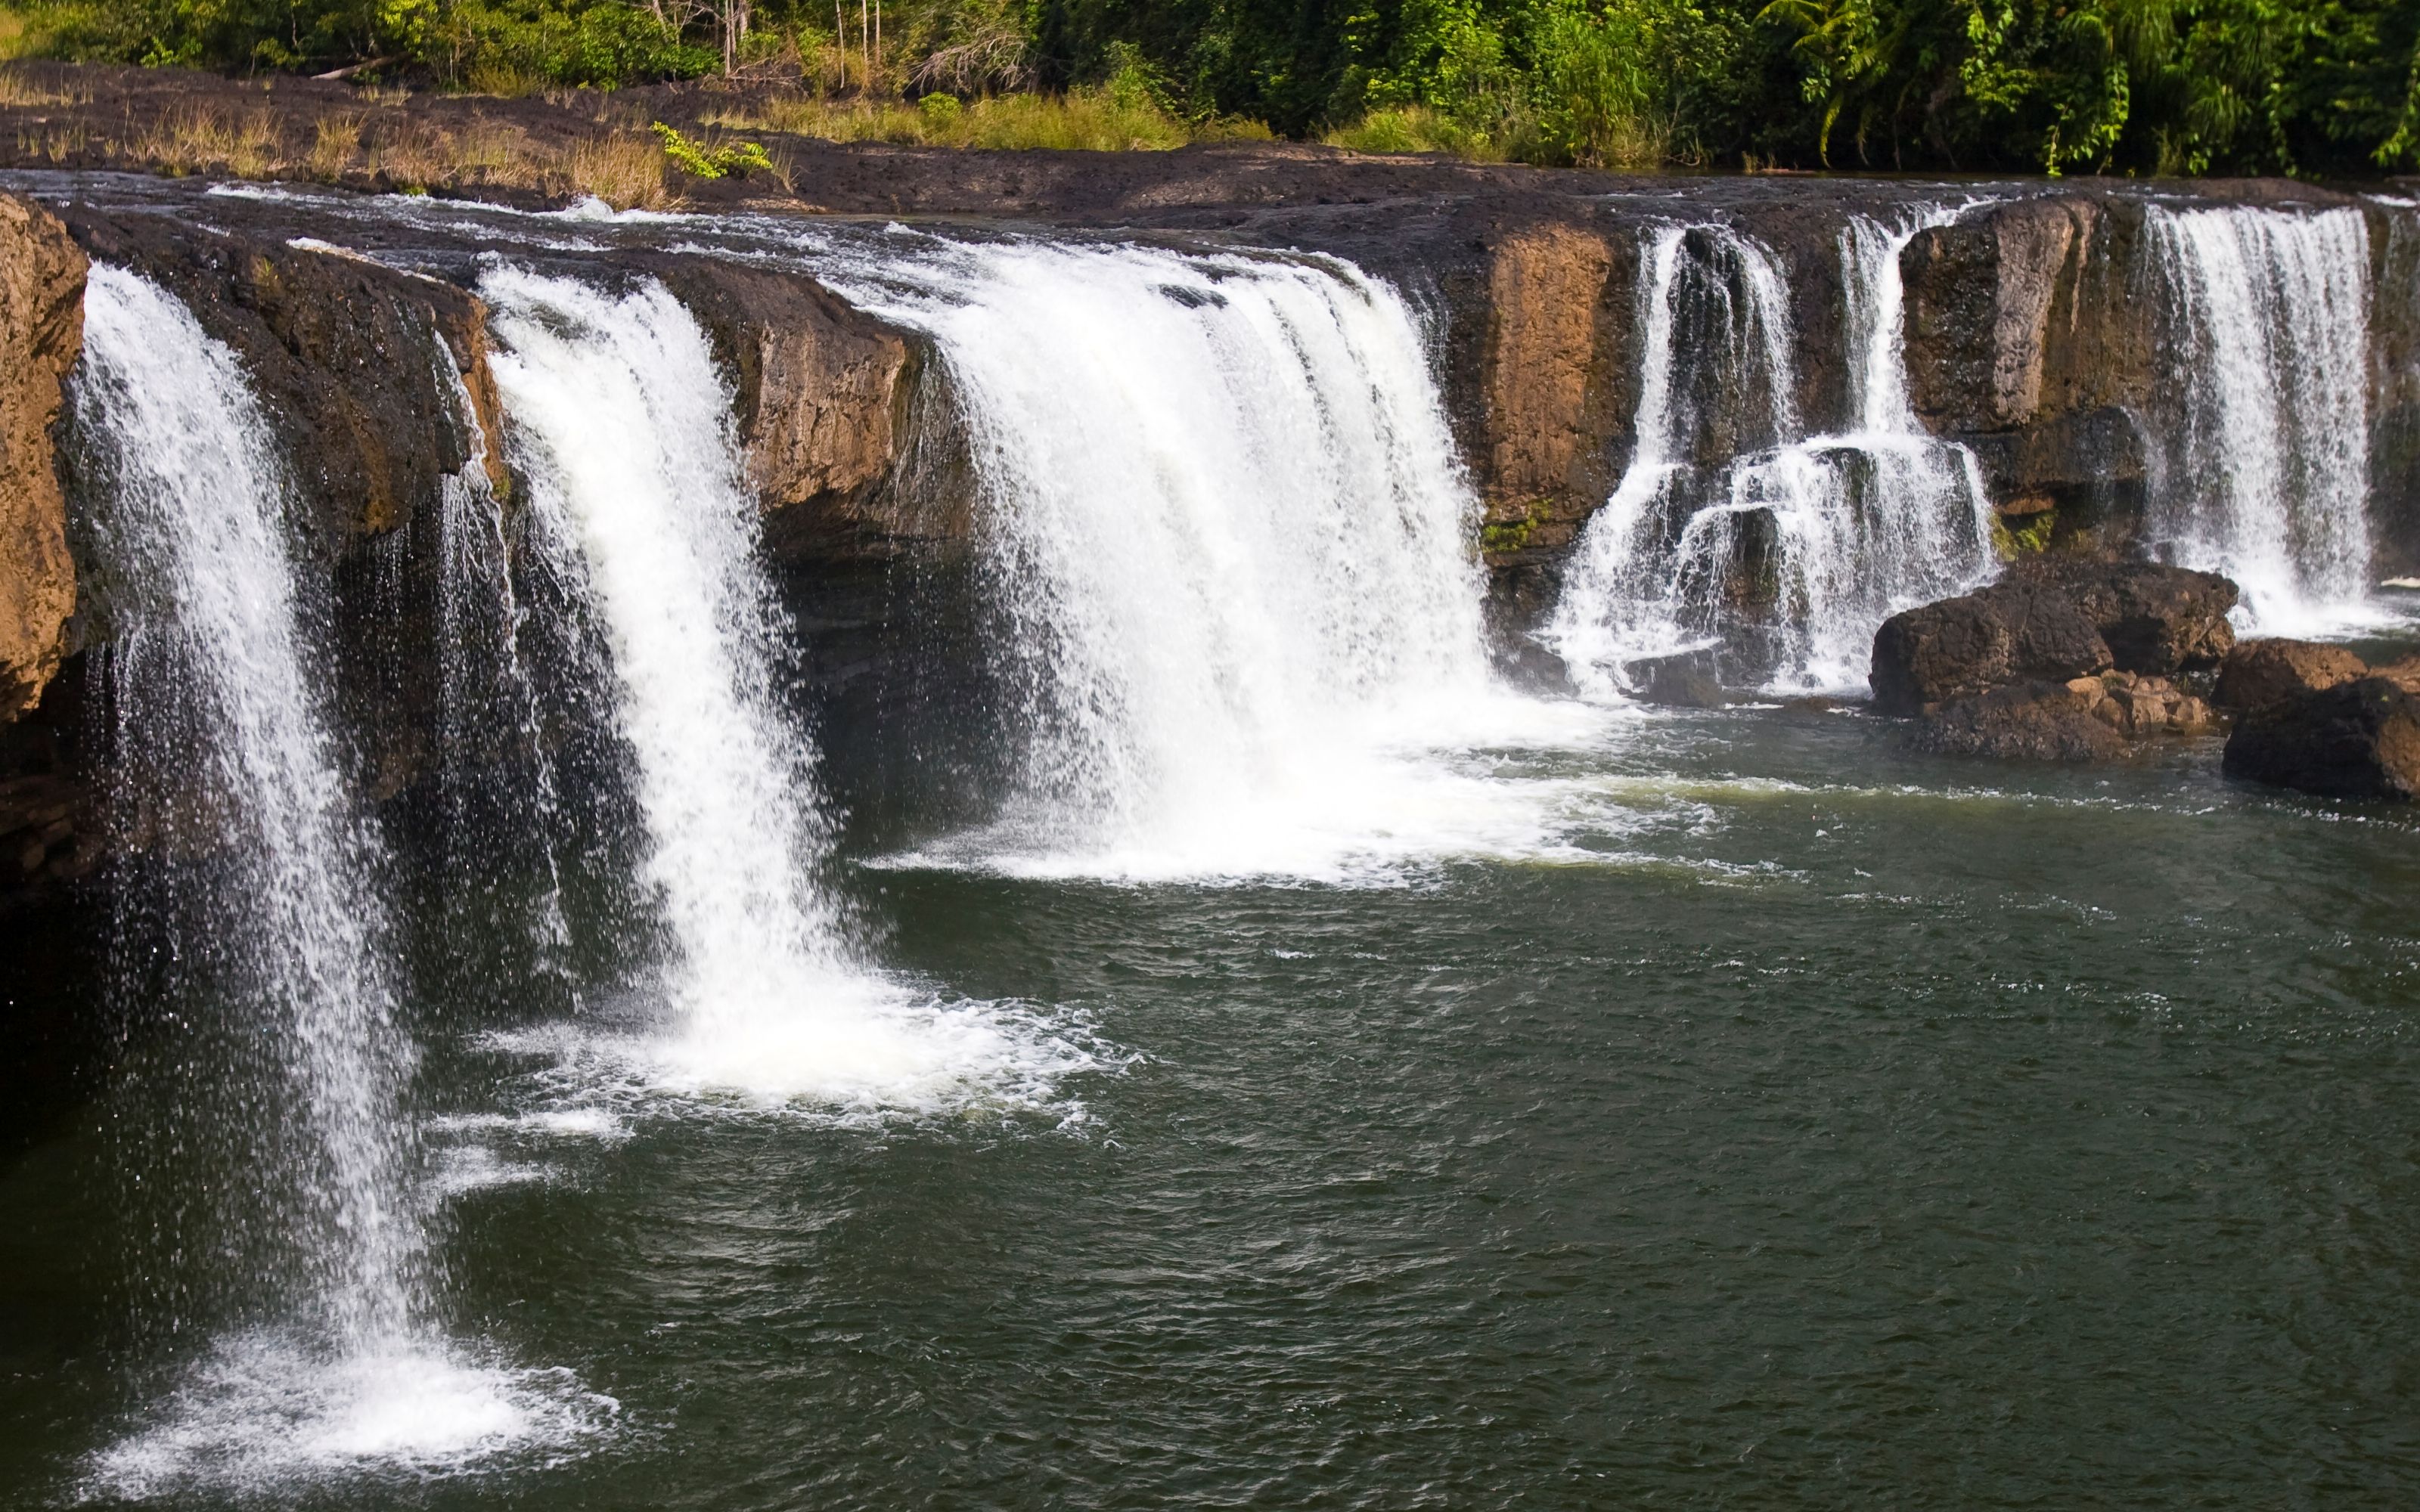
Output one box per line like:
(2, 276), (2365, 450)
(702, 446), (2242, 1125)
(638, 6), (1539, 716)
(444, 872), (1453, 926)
(77, 1333), (622, 1502)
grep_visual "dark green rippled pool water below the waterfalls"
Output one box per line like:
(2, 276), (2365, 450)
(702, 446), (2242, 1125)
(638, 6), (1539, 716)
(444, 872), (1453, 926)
(0, 709), (2420, 1507)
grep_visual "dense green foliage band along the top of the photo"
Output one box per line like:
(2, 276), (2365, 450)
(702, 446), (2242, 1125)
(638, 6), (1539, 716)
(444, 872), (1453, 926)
(17, 0), (2420, 174)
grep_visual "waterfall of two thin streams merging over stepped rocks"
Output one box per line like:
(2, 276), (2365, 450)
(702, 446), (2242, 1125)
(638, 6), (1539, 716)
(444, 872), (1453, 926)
(1544, 210), (1992, 692)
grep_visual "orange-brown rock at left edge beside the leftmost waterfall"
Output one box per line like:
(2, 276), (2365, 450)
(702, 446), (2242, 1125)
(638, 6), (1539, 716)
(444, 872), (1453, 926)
(0, 196), (85, 726)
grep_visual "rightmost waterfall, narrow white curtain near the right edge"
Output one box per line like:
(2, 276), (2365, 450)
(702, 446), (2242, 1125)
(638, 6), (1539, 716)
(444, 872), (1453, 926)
(2149, 206), (2369, 634)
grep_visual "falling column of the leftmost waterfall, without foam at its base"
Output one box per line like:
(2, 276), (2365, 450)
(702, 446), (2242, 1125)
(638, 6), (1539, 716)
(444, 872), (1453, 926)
(75, 266), (424, 1352)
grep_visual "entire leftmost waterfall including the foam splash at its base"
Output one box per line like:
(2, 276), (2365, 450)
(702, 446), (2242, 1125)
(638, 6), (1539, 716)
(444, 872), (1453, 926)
(75, 266), (610, 1495)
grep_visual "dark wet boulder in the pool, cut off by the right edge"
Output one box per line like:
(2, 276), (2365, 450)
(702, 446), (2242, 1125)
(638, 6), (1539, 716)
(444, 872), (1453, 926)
(2226, 677), (2420, 801)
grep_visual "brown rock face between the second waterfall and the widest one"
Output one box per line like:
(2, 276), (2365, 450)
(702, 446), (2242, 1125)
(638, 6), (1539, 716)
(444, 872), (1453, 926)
(649, 259), (970, 559)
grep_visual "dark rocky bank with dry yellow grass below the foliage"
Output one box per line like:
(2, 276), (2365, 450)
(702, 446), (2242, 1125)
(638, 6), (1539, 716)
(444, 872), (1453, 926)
(0, 63), (1655, 220)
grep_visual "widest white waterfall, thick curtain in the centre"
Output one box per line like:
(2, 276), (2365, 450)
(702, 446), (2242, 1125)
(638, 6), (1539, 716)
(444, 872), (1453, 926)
(839, 242), (1597, 878)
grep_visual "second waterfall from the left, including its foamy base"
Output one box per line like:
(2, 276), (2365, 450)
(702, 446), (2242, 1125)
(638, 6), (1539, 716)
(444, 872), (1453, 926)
(482, 268), (1079, 1108)
